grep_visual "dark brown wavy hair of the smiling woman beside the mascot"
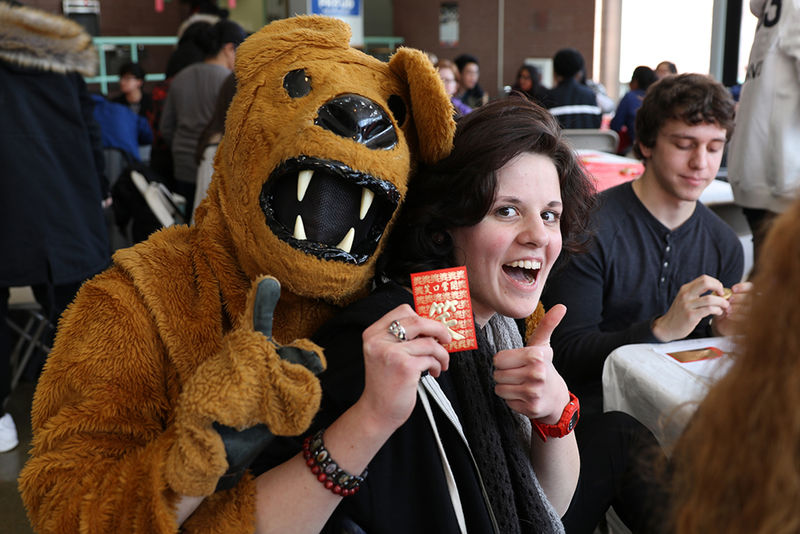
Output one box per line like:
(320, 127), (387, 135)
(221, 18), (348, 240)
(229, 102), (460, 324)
(378, 97), (595, 285)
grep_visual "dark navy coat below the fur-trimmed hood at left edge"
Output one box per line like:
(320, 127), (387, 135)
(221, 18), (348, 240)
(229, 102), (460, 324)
(0, 61), (110, 287)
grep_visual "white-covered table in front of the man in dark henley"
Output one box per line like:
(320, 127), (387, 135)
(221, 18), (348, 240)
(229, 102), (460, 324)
(603, 337), (733, 452)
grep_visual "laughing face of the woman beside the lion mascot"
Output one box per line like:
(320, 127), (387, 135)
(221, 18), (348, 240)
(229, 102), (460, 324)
(450, 152), (562, 325)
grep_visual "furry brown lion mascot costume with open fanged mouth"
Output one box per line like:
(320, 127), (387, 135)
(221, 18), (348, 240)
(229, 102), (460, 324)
(20, 16), (455, 534)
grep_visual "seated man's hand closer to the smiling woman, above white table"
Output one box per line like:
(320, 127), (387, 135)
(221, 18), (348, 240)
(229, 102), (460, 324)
(651, 274), (731, 342)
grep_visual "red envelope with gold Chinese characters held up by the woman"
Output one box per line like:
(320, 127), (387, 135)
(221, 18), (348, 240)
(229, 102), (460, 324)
(411, 267), (478, 352)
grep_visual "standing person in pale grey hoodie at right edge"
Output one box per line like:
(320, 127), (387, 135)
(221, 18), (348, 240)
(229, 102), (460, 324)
(728, 0), (800, 269)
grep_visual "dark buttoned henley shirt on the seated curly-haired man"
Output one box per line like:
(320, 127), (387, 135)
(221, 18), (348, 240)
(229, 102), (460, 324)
(542, 183), (744, 412)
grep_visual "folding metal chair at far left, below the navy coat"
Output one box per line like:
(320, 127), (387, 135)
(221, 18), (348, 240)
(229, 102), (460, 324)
(6, 286), (53, 391)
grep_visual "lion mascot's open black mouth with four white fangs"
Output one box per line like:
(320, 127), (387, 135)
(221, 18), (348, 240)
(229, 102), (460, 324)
(260, 156), (400, 265)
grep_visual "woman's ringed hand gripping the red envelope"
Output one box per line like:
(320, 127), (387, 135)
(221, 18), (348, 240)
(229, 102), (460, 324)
(358, 304), (451, 436)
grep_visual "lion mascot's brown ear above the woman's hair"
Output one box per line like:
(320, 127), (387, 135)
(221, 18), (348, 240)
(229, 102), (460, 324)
(389, 48), (456, 164)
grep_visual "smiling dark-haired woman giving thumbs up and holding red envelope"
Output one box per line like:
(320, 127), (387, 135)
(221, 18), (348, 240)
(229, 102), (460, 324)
(245, 98), (593, 533)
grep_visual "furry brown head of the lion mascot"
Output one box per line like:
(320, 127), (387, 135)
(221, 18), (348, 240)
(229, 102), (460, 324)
(198, 16), (455, 304)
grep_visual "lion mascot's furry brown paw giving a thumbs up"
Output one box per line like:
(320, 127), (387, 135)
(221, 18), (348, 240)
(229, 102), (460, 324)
(167, 277), (325, 495)
